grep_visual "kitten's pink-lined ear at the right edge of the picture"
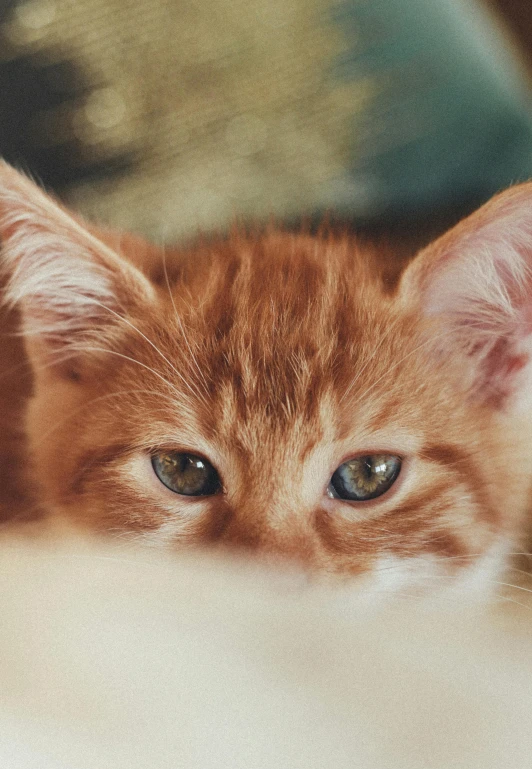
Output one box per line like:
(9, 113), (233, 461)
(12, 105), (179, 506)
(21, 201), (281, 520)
(399, 183), (532, 407)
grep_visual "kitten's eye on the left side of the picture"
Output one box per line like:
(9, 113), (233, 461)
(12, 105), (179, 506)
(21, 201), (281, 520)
(151, 451), (222, 497)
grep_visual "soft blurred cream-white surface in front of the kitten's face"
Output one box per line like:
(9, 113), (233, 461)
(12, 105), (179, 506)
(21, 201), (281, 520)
(0, 542), (532, 769)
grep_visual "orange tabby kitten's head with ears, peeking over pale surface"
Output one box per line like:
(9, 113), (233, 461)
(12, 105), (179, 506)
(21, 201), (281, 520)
(0, 165), (532, 584)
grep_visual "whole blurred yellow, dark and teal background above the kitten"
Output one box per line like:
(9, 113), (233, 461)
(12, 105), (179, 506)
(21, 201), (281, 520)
(0, 0), (532, 246)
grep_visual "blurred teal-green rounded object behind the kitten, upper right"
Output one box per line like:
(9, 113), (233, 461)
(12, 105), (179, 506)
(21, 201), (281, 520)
(328, 0), (532, 218)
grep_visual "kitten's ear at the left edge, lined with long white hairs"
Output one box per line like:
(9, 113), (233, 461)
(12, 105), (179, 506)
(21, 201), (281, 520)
(0, 161), (154, 364)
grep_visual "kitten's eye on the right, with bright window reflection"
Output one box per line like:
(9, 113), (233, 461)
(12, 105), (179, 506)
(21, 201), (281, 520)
(327, 454), (401, 502)
